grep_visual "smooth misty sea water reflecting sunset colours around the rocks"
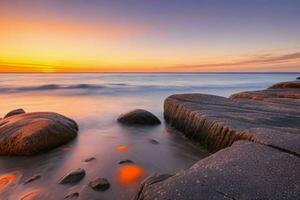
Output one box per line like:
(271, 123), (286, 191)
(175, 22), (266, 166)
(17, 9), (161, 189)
(0, 73), (300, 200)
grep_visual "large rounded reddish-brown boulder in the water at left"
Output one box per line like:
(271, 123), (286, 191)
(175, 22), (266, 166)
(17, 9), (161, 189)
(0, 112), (78, 155)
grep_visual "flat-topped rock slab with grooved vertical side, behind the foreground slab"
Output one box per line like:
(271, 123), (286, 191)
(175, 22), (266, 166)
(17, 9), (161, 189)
(164, 94), (300, 155)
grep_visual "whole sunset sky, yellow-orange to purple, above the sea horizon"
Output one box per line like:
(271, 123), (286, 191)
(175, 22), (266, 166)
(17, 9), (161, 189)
(0, 0), (300, 72)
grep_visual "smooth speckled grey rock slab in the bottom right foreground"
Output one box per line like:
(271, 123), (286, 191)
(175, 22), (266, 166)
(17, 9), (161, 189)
(135, 141), (300, 200)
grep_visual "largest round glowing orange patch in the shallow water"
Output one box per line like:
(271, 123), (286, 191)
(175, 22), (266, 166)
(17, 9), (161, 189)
(117, 164), (144, 184)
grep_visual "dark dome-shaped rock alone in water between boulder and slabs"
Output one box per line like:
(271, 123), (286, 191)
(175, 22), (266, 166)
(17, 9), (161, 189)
(118, 109), (161, 125)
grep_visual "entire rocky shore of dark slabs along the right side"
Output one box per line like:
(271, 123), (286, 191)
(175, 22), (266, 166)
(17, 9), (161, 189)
(135, 81), (300, 200)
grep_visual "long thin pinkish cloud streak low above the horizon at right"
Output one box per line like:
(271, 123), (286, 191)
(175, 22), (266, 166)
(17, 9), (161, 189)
(173, 52), (300, 70)
